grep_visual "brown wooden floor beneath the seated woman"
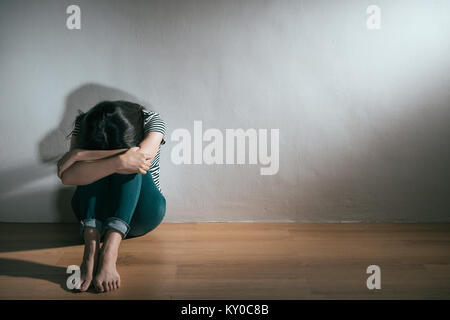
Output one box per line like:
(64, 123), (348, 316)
(0, 223), (450, 299)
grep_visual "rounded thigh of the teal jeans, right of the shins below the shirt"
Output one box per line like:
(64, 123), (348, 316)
(128, 171), (166, 238)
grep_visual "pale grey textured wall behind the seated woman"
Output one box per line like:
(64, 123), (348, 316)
(0, 0), (450, 222)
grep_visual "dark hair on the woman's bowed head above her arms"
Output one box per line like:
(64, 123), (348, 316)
(69, 100), (144, 150)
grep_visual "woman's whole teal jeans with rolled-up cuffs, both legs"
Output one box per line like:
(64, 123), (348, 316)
(71, 171), (166, 238)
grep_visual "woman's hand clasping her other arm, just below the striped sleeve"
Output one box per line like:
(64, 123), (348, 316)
(116, 147), (152, 174)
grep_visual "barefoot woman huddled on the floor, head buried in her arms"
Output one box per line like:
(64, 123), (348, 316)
(58, 101), (166, 292)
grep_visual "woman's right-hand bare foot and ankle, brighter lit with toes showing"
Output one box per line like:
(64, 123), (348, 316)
(94, 232), (121, 292)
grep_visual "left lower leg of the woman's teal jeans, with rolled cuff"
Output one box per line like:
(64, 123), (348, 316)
(71, 176), (109, 238)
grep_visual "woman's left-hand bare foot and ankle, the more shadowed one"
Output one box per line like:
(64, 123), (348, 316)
(80, 228), (100, 291)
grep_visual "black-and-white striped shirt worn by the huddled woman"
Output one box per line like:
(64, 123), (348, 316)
(72, 109), (166, 192)
